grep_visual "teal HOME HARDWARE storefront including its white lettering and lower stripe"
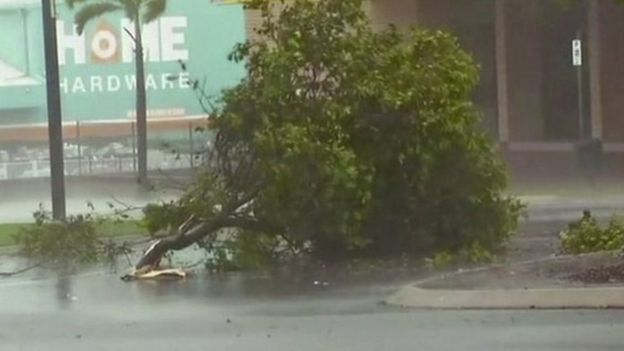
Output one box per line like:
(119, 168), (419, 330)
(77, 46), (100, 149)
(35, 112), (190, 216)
(0, 0), (246, 142)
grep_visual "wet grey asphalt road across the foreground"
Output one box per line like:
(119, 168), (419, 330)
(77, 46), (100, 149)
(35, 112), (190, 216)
(0, 272), (624, 351)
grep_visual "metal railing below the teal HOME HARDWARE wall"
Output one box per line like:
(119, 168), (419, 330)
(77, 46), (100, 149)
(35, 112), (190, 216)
(0, 119), (209, 180)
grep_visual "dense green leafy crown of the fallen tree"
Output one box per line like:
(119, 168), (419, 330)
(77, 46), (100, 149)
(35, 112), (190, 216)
(151, 0), (522, 266)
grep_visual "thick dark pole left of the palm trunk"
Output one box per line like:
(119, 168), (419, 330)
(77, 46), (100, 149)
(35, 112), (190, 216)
(41, 0), (65, 220)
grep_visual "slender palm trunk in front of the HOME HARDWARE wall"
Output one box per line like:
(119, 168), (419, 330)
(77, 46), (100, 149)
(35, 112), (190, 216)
(134, 17), (147, 185)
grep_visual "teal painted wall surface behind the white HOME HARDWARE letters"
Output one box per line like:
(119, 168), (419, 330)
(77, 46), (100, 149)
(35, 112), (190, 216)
(0, 0), (245, 125)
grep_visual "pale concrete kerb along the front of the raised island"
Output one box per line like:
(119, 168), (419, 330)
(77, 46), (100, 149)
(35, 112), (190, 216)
(386, 284), (624, 309)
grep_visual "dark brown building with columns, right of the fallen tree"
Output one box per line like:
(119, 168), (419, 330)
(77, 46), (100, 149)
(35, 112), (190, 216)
(360, 0), (624, 174)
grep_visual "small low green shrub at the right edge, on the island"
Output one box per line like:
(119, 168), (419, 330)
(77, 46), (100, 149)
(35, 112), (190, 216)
(560, 212), (624, 254)
